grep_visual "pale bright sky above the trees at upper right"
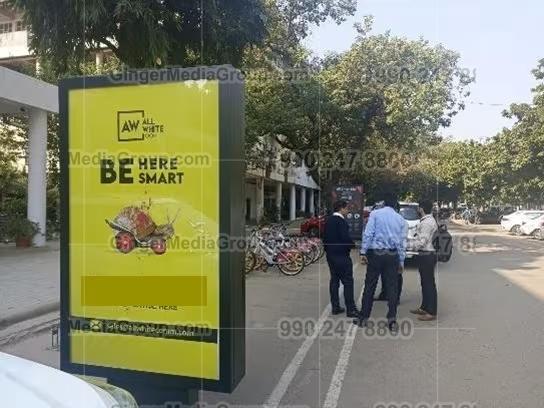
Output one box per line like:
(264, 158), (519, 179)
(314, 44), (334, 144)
(306, 0), (544, 140)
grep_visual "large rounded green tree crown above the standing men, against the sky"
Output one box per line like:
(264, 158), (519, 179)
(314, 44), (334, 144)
(323, 18), (473, 153)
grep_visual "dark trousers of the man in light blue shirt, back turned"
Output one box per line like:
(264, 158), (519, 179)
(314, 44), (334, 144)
(361, 251), (399, 321)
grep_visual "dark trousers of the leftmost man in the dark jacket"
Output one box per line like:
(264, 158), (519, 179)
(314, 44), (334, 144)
(327, 254), (356, 311)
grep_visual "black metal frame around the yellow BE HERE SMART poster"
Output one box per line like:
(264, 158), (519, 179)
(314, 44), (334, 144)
(59, 66), (245, 396)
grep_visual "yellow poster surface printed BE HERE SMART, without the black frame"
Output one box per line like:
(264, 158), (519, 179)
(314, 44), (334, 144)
(68, 81), (220, 379)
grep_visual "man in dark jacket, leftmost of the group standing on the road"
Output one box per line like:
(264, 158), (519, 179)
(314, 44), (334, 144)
(323, 201), (358, 317)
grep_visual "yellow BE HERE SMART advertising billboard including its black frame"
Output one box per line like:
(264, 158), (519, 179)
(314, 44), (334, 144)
(60, 70), (244, 391)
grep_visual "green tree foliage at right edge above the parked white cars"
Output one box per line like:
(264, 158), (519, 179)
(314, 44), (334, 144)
(422, 60), (544, 207)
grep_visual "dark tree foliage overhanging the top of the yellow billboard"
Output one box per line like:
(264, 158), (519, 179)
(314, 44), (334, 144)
(10, 0), (266, 73)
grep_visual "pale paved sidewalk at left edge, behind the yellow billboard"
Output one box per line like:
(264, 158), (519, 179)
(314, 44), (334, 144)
(0, 241), (60, 330)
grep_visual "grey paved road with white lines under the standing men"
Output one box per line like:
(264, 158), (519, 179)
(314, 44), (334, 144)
(7, 226), (544, 408)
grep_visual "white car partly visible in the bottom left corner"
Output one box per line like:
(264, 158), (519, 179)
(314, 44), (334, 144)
(0, 353), (137, 408)
